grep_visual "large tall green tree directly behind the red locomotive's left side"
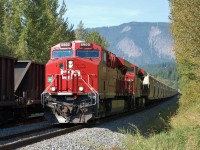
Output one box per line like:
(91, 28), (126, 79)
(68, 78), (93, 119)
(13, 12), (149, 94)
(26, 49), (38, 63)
(25, 0), (74, 62)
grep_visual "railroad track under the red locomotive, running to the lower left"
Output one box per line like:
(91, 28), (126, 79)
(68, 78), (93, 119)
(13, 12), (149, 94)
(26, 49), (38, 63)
(0, 96), (175, 150)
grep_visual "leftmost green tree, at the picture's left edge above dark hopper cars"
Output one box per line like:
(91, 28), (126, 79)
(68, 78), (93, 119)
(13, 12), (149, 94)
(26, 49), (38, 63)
(1, 0), (24, 57)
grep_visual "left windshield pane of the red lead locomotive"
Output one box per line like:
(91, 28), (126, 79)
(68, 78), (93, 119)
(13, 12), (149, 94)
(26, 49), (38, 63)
(52, 49), (73, 58)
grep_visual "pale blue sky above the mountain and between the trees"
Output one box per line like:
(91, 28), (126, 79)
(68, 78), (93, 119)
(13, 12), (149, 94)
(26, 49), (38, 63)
(59, 0), (170, 29)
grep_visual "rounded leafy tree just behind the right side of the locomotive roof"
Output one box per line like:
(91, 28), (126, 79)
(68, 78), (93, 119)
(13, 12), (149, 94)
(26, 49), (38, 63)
(85, 31), (109, 49)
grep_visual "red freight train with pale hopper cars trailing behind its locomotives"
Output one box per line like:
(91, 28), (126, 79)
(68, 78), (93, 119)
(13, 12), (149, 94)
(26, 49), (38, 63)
(41, 41), (177, 123)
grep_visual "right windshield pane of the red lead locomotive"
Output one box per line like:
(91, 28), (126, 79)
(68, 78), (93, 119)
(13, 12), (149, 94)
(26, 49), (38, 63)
(76, 49), (99, 58)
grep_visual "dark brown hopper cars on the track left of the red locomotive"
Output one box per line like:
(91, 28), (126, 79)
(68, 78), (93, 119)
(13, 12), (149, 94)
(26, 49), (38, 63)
(0, 56), (45, 124)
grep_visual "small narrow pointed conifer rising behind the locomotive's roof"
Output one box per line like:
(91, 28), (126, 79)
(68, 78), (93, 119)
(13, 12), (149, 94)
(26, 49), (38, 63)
(75, 21), (86, 41)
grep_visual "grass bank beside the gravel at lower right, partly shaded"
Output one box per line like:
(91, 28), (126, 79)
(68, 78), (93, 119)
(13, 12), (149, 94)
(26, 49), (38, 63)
(120, 97), (200, 150)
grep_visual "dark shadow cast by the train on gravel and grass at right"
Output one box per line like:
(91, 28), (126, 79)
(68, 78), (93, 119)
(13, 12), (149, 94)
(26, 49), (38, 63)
(96, 96), (179, 137)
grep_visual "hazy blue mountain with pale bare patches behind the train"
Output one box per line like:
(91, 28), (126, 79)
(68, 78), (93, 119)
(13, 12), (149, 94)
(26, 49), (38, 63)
(87, 22), (174, 65)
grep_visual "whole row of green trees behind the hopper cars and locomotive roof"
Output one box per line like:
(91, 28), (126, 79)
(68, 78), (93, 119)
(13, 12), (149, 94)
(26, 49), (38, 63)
(0, 0), (108, 62)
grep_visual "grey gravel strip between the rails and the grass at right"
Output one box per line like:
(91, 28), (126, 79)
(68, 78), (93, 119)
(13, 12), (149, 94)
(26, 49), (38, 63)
(16, 98), (177, 150)
